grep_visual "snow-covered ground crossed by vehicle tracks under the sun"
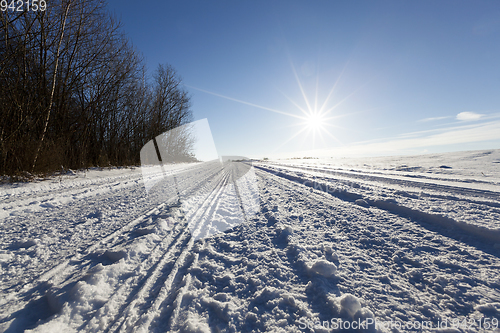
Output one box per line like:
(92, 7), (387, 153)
(0, 150), (500, 332)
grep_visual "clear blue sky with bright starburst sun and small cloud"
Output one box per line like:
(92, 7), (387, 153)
(108, 0), (500, 157)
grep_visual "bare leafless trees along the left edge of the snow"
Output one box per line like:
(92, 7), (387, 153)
(0, 0), (192, 175)
